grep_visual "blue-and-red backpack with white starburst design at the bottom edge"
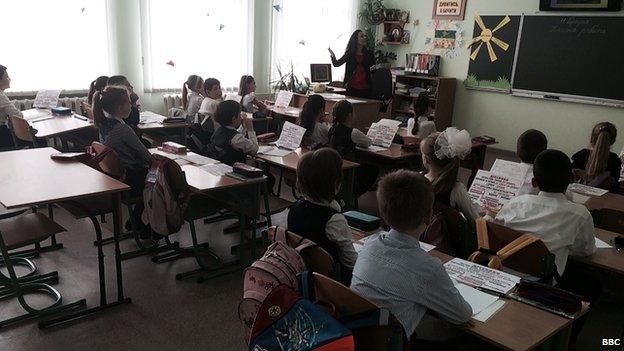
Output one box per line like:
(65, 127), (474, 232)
(249, 284), (355, 351)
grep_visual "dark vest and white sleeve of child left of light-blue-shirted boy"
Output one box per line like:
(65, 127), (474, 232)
(288, 198), (358, 271)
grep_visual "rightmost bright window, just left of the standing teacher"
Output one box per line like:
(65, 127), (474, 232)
(271, 0), (358, 87)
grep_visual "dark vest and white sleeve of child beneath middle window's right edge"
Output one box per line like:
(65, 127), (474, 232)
(211, 126), (258, 166)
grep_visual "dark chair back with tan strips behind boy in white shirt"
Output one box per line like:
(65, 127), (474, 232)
(468, 218), (557, 282)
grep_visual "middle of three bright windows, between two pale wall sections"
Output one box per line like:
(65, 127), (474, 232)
(141, 0), (253, 92)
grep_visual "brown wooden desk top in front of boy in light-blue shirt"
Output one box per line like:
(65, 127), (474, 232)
(353, 231), (589, 350)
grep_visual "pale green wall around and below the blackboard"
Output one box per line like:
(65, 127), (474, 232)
(366, 0), (624, 154)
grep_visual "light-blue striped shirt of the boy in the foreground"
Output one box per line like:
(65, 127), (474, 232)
(351, 229), (472, 338)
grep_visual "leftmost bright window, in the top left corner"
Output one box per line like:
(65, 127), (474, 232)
(0, 0), (111, 93)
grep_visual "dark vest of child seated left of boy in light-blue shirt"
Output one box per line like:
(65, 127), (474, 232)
(288, 199), (340, 262)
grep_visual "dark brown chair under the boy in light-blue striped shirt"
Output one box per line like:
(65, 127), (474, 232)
(300, 273), (406, 351)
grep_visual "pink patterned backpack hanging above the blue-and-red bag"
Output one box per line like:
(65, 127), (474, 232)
(238, 227), (316, 343)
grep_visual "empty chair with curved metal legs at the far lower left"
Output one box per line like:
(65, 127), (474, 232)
(0, 213), (86, 328)
